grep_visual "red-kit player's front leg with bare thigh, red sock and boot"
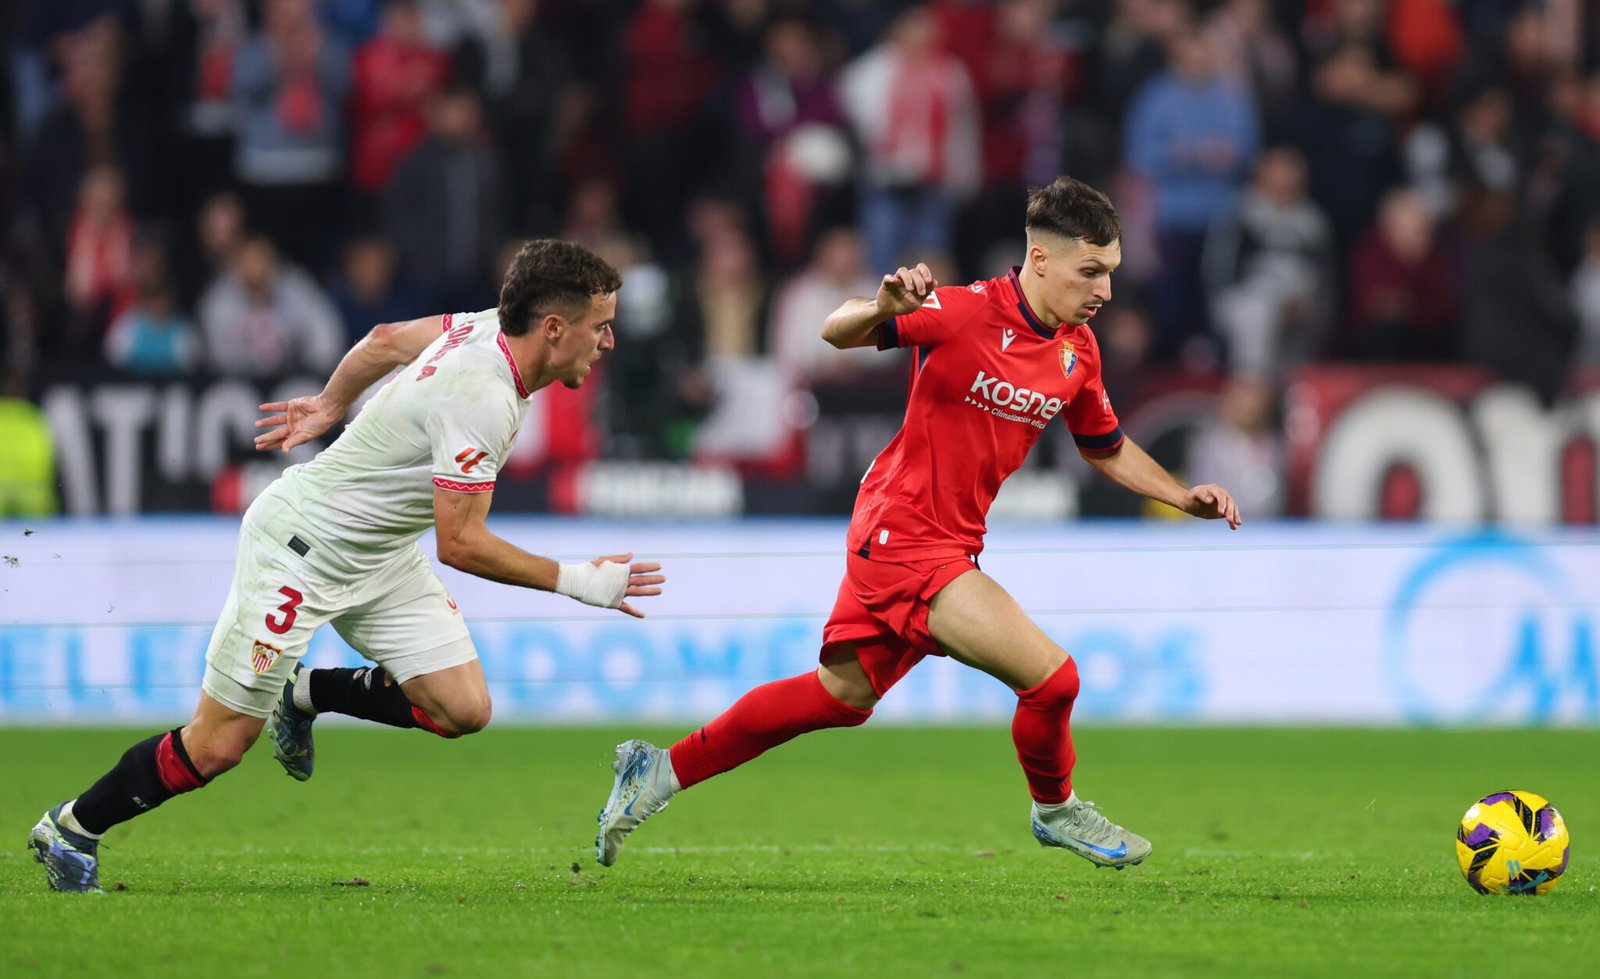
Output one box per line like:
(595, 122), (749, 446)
(928, 571), (1150, 870)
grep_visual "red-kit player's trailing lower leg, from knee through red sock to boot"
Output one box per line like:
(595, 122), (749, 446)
(595, 643), (878, 867)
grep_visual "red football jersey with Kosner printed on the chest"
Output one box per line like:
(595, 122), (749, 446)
(848, 269), (1122, 560)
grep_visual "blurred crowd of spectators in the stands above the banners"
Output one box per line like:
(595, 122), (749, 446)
(0, 0), (1600, 515)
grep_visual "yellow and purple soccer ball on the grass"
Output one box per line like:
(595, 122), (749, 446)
(1456, 790), (1571, 894)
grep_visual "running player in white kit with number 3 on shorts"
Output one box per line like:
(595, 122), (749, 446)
(29, 240), (664, 891)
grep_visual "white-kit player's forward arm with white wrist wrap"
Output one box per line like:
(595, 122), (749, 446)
(434, 486), (667, 619)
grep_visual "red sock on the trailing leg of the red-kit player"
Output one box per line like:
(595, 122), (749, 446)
(672, 670), (872, 789)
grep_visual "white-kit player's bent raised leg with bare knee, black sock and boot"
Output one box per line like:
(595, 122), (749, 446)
(269, 640), (493, 782)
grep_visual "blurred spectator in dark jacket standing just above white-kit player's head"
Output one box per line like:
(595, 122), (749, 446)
(384, 88), (507, 309)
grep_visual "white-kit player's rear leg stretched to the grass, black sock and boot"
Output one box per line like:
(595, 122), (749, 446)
(29, 693), (264, 893)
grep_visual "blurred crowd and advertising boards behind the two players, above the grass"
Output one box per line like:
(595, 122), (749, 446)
(0, 0), (1600, 725)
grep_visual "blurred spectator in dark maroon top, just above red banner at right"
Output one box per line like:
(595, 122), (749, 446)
(1334, 189), (1461, 362)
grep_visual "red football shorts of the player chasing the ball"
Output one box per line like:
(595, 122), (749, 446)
(822, 553), (978, 697)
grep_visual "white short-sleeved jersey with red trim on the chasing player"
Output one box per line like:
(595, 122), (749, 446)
(251, 309), (530, 571)
